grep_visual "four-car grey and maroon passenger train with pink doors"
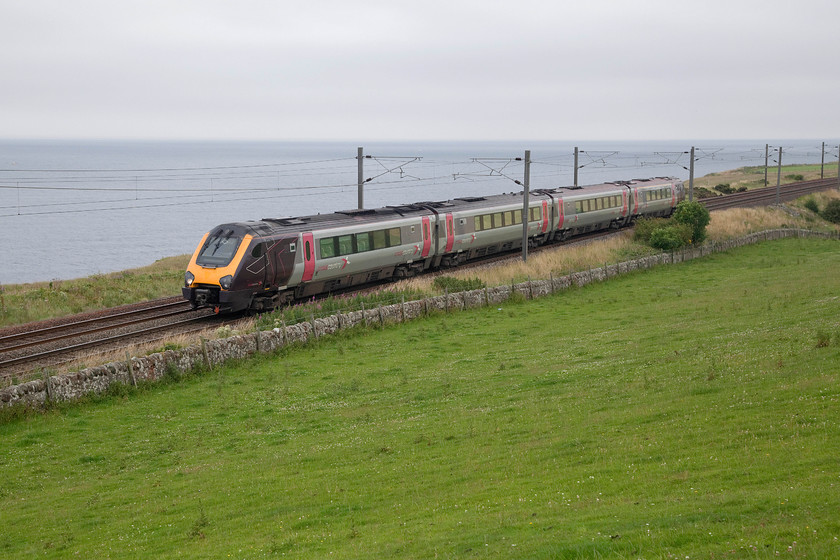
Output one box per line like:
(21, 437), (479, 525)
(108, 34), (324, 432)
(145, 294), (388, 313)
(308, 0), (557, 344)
(183, 177), (685, 313)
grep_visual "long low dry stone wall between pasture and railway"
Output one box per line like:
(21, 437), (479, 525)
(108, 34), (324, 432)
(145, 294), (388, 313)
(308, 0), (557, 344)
(0, 229), (838, 407)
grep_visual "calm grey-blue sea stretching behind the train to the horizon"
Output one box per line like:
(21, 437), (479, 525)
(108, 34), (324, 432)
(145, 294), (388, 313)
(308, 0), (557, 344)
(0, 139), (837, 285)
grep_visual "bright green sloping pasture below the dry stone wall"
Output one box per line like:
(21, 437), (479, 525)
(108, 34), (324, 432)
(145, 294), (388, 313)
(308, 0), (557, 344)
(0, 239), (840, 559)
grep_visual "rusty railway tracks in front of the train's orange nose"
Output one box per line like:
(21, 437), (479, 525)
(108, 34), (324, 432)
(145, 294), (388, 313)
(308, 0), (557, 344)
(0, 297), (226, 379)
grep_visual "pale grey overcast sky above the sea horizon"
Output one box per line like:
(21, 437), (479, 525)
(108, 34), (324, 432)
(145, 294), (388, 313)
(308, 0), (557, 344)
(0, 0), (840, 141)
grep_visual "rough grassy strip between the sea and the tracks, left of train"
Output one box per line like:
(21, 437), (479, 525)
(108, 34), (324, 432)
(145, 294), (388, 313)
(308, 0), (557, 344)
(0, 255), (190, 327)
